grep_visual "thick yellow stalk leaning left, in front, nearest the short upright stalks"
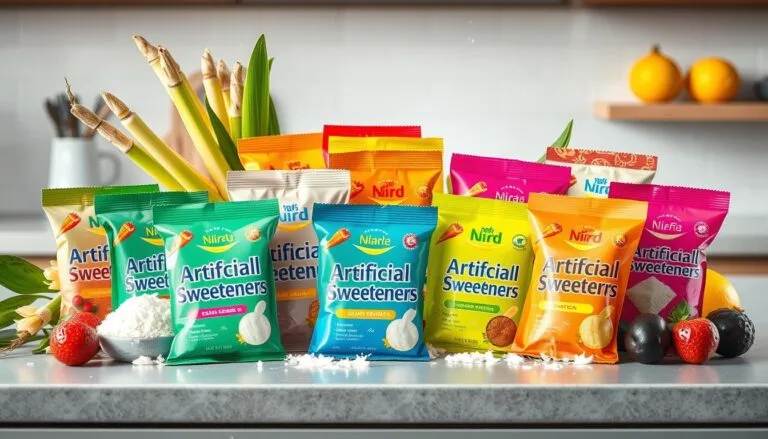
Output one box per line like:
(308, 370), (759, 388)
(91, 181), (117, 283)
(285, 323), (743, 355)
(158, 48), (229, 199)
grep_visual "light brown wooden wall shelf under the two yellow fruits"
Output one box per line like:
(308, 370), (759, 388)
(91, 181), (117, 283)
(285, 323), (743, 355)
(593, 102), (768, 122)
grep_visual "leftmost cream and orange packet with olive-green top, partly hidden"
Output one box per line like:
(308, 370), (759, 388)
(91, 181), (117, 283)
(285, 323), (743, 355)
(42, 184), (159, 319)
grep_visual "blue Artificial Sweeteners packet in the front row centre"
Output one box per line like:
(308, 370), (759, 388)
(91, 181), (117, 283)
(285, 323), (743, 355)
(309, 204), (437, 361)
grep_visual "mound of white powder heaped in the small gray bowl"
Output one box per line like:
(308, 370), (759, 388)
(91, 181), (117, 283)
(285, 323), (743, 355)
(96, 294), (173, 338)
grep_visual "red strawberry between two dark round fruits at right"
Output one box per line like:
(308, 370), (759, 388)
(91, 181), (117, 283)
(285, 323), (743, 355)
(672, 318), (720, 364)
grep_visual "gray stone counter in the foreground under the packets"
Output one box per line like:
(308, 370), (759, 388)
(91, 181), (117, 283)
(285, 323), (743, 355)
(0, 278), (768, 428)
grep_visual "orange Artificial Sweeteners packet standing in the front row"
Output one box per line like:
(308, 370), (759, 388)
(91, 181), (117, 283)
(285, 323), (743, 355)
(512, 194), (648, 363)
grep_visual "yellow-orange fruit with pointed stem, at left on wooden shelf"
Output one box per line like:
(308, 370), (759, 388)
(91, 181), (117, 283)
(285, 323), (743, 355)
(629, 45), (683, 103)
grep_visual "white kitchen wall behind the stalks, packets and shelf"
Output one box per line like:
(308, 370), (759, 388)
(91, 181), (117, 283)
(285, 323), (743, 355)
(0, 3), (768, 215)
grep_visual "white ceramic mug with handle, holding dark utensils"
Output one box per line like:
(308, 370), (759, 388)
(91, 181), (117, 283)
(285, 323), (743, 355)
(48, 137), (120, 188)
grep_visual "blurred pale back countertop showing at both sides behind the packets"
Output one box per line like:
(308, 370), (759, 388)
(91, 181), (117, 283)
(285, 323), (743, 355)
(0, 213), (768, 256)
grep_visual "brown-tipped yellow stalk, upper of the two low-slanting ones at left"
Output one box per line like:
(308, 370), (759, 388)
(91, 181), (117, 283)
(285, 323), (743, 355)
(101, 93), (222, 201)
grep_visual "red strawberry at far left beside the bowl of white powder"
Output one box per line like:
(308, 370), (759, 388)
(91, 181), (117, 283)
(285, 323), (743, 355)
(50, 319), (99, 366)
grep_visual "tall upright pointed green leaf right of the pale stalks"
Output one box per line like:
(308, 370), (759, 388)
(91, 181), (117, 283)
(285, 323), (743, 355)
(242, 35), (269, 138)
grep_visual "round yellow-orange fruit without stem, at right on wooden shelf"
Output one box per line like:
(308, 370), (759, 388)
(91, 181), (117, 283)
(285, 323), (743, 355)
(686, 57), (741, 104)
